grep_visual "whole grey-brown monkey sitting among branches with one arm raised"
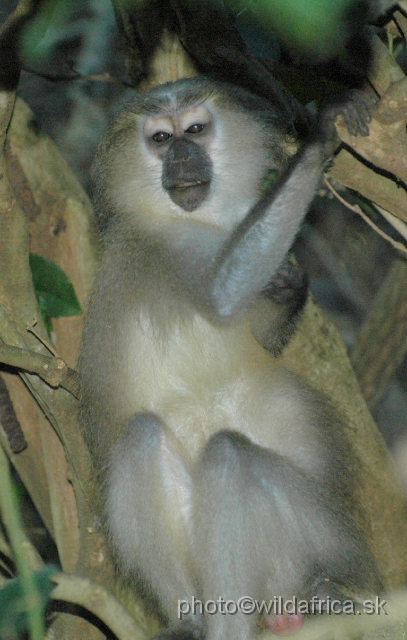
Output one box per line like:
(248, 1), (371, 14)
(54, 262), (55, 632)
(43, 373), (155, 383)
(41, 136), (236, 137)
(78, 76), (381, 640)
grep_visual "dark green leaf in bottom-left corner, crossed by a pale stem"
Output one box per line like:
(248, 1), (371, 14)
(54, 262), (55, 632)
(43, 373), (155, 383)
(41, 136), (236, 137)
(0, 566), (59, 640)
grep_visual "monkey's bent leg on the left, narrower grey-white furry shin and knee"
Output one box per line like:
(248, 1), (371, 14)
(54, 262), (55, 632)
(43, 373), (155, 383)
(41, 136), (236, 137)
(107, 413), (201, 638)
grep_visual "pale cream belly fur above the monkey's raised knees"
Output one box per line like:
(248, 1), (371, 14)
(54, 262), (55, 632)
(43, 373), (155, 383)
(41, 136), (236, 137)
(122, 319), (324, 467)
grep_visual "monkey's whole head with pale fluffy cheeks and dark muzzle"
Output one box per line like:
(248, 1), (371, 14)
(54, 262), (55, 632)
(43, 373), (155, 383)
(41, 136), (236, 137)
(94, 78), (284, 232)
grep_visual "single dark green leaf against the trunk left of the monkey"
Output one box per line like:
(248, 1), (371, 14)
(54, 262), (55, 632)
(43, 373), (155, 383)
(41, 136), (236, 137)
(30, 253), (82, 332)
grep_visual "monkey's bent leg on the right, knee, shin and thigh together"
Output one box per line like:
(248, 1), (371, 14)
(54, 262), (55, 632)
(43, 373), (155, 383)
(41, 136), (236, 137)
(193, 431), (376, 640)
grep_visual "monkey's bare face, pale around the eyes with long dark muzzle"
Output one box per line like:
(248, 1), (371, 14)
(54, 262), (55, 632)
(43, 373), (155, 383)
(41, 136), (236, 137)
(144, 105), (214, 211)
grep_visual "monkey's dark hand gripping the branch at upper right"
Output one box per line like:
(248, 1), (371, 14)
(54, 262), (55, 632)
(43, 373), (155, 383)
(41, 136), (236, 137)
(314, 89), (378, 158)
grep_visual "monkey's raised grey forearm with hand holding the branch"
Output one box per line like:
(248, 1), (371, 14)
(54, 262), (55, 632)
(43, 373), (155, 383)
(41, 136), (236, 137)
(209, 92), (370, 316)
